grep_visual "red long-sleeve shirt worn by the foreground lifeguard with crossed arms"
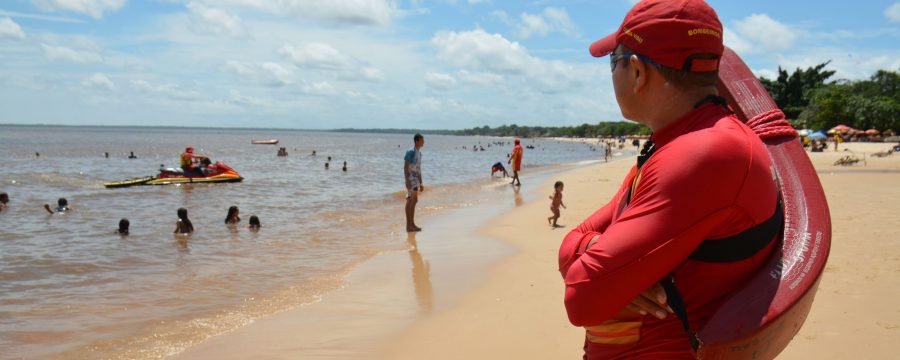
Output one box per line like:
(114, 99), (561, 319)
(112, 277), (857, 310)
(559, 104), (777, 358)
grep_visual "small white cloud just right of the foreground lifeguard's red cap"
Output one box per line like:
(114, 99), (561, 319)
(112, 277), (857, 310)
(724, 14), (799, 53)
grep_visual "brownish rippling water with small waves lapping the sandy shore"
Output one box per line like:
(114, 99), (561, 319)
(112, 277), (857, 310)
(0, 128), (621, 359)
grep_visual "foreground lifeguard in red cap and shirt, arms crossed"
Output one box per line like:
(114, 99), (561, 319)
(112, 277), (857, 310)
(559, 0), (783, 359)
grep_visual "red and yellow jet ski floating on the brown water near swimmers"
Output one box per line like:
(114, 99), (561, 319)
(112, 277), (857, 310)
(103, 159), (244, 188)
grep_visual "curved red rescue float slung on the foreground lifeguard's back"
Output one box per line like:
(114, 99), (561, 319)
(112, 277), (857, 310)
(696, 48), (831, 359)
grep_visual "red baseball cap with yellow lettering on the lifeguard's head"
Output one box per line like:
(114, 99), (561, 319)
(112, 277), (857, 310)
(591, 0), (725, 72)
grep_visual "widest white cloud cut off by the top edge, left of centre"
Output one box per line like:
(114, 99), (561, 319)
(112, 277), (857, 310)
(193, 0), (399, 26)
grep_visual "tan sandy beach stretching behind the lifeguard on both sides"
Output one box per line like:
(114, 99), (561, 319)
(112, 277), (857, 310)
(179, 144), (900, 359)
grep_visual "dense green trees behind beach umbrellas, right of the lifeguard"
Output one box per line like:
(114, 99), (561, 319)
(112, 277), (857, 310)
(759, 62), (900, 131)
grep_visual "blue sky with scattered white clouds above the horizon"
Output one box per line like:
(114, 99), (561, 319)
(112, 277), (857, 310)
(0, 0), (900, 129)
